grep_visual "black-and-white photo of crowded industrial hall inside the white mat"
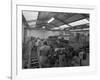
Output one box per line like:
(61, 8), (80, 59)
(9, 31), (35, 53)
(22, 10), (90, 69)
